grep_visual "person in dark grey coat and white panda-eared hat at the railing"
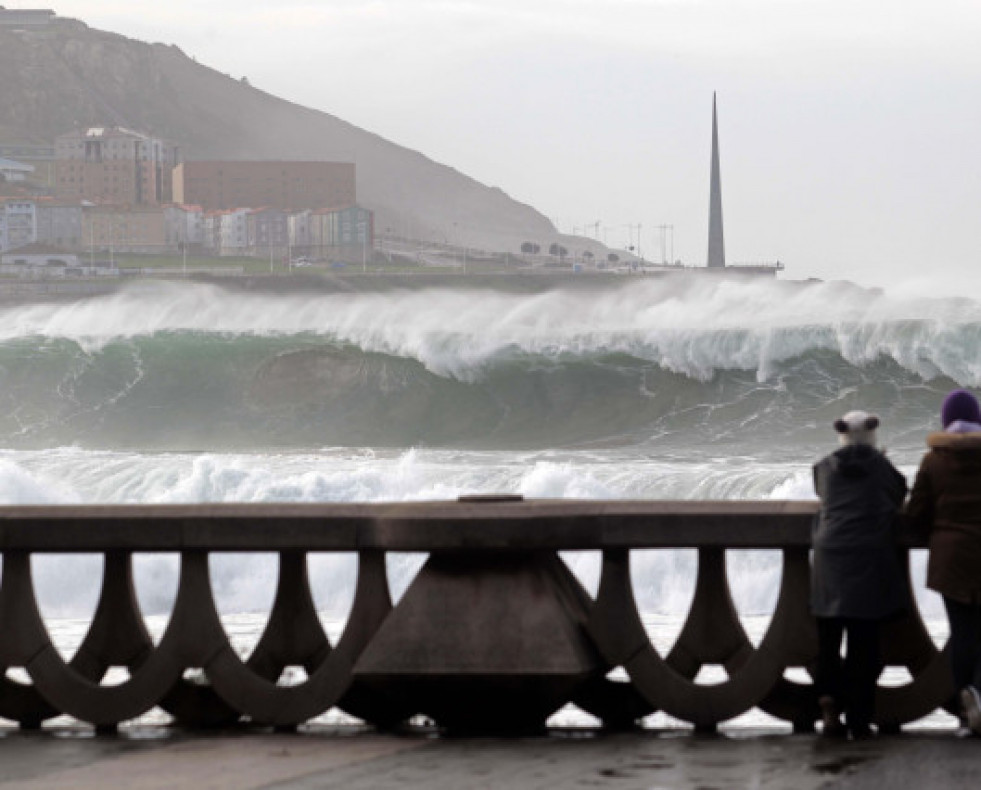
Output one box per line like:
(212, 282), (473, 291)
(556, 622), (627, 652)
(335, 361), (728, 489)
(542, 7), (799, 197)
(811, 411), (908, 738)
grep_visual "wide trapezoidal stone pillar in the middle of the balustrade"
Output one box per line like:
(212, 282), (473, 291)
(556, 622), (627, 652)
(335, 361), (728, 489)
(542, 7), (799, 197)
(354, 552), (608, 733)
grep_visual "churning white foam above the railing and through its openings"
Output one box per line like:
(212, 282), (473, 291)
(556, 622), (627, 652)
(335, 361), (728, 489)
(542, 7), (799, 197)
(0, 448), (941, 617)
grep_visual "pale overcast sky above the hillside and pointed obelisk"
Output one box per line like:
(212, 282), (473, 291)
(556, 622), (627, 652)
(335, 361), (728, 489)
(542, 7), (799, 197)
(17, 0), (981, 296)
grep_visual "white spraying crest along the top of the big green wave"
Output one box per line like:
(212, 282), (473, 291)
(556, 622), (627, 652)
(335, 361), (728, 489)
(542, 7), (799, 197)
(0, 277), (981, 385)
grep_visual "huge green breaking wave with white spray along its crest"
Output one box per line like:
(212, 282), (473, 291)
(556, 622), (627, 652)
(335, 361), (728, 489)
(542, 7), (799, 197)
(0, 276), (981, 450)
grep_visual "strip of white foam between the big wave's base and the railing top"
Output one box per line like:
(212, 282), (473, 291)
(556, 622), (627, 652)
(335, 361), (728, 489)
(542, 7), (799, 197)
(0, 448), (813, 504)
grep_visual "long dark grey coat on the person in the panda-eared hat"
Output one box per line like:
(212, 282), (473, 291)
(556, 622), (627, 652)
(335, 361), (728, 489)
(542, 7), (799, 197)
(811, 445), (909, 620)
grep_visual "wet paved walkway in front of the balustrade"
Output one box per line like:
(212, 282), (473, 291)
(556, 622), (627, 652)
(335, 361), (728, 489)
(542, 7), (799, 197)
(0, 727), (981, 790)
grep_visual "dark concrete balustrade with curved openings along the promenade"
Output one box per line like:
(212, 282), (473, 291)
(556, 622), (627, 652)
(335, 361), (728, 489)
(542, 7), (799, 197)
(0, 504), (952, 731)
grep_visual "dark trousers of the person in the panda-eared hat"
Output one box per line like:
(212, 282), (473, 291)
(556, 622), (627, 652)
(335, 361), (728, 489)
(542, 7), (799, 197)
(814, 617), (882, 726)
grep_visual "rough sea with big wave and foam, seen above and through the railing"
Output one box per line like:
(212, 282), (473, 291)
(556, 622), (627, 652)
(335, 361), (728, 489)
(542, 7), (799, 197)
(0, 276), (968, 732)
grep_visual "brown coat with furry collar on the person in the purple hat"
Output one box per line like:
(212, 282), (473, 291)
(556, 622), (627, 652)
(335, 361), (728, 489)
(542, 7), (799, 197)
(906, 433), (981, 603)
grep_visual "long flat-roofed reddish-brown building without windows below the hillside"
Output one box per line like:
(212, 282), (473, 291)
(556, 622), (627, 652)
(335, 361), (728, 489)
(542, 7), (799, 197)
(174, 161), (356, 211)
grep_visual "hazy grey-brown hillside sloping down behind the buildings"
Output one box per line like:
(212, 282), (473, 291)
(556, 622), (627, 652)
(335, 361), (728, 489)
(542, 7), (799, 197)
(0, 20), (556, 250)
